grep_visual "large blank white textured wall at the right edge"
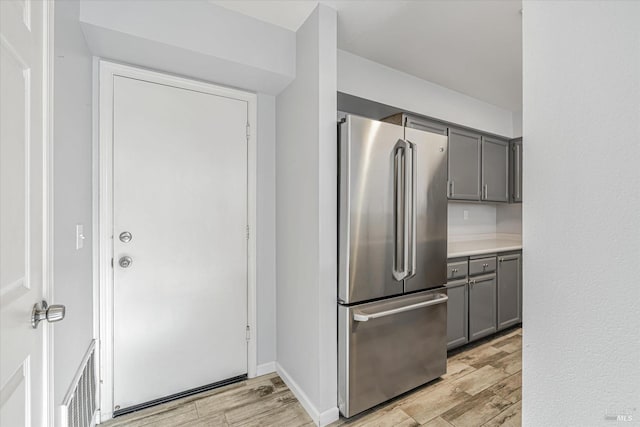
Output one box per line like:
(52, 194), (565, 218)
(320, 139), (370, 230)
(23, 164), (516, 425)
(522, 1), (640, 426)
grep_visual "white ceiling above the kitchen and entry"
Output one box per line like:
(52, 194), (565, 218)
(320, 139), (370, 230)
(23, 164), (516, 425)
(210, 0), (522, 111)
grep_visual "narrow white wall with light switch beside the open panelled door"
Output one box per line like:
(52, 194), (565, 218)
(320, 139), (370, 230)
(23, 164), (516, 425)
(49, 0), (93, 414)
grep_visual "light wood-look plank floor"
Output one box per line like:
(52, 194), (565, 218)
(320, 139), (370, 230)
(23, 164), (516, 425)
(104, 328), (522, 427)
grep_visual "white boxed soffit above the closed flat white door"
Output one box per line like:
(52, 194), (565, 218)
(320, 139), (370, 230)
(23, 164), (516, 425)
(80, 0), (295, 95)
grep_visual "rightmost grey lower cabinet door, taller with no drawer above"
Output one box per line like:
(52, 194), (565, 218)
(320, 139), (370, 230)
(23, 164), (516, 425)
(498, 254), (522, 330)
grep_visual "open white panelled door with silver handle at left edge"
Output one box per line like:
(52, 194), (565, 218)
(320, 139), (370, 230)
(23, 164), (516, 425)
(0, 1), (48, 426)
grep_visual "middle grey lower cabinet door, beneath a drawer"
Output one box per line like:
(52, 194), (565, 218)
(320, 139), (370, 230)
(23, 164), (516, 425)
(469, 274), (496, 341)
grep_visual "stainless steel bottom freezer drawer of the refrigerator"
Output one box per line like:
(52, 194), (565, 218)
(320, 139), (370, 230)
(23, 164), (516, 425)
(338, 288), (447, 417)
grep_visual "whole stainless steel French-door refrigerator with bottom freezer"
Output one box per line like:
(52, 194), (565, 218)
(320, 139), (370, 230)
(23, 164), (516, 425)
(338, 115), (447, 417)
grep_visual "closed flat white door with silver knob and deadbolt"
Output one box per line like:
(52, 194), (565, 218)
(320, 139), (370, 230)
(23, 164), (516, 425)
(113, 76), (248, 414)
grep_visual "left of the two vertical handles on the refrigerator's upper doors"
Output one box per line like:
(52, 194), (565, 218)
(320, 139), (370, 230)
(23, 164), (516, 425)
(393, 139), (411, 281)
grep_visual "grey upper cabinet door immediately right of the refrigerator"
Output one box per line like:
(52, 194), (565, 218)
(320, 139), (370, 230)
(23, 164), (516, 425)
(448, 128), (481, 200)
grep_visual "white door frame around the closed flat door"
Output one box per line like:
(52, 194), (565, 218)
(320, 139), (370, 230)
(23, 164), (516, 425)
(93, 58), (257, 422)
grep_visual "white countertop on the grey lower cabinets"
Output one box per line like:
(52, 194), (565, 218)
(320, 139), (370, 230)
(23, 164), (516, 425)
(447, 234), (522, 258)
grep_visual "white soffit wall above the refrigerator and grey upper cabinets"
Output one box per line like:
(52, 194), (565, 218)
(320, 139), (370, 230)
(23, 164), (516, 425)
(338, 50), (520, 137)
